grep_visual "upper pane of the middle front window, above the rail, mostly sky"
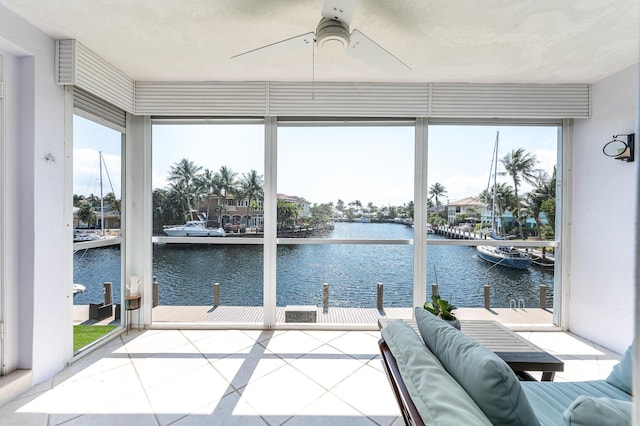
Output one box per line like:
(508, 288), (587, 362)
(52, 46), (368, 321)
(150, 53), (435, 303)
(278, 126), (415, 239)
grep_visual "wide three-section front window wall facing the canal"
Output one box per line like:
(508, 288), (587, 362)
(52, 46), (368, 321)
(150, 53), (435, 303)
(146, 120), (559, 324)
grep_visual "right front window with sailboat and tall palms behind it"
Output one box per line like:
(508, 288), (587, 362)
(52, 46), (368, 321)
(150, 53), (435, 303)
(427, 125), (558, 308)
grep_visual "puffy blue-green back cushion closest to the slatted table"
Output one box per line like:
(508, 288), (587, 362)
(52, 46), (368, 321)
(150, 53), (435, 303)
(415, 308), (540, 425)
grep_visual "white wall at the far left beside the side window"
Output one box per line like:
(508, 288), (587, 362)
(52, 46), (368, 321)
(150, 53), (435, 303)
(0, 6), (73, 384)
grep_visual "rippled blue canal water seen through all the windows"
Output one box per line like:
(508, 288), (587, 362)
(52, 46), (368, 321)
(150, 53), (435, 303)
(74, 223), (553, 307)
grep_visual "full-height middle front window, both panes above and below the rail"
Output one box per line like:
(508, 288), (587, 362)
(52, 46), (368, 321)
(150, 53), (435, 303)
(276, 122), (415, 324)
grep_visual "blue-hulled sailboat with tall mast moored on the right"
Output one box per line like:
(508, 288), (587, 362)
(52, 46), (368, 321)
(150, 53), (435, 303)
(476, 131), (531, 269)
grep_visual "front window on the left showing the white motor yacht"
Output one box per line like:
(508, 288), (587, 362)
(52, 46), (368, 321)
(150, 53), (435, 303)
(152, 123), (264, 323)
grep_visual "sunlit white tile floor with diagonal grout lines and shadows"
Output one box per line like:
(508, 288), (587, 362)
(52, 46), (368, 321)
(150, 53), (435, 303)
(0, 330), (619, 426)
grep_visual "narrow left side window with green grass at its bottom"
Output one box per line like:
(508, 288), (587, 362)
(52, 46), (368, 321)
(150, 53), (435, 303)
(73, 116), (122, 352)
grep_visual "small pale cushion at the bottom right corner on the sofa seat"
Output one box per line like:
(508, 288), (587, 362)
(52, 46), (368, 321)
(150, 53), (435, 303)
(564, 396), (632, 426)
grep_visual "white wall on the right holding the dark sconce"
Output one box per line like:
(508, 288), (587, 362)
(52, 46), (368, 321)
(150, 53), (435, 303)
(568, 64), (640, 352)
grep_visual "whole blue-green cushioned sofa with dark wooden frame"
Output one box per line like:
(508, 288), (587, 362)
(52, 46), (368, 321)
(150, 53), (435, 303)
(380, 308), (632, 426)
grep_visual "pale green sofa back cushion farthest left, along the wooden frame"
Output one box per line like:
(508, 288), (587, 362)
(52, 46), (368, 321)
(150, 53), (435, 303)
(381, 321), (491, 425)
